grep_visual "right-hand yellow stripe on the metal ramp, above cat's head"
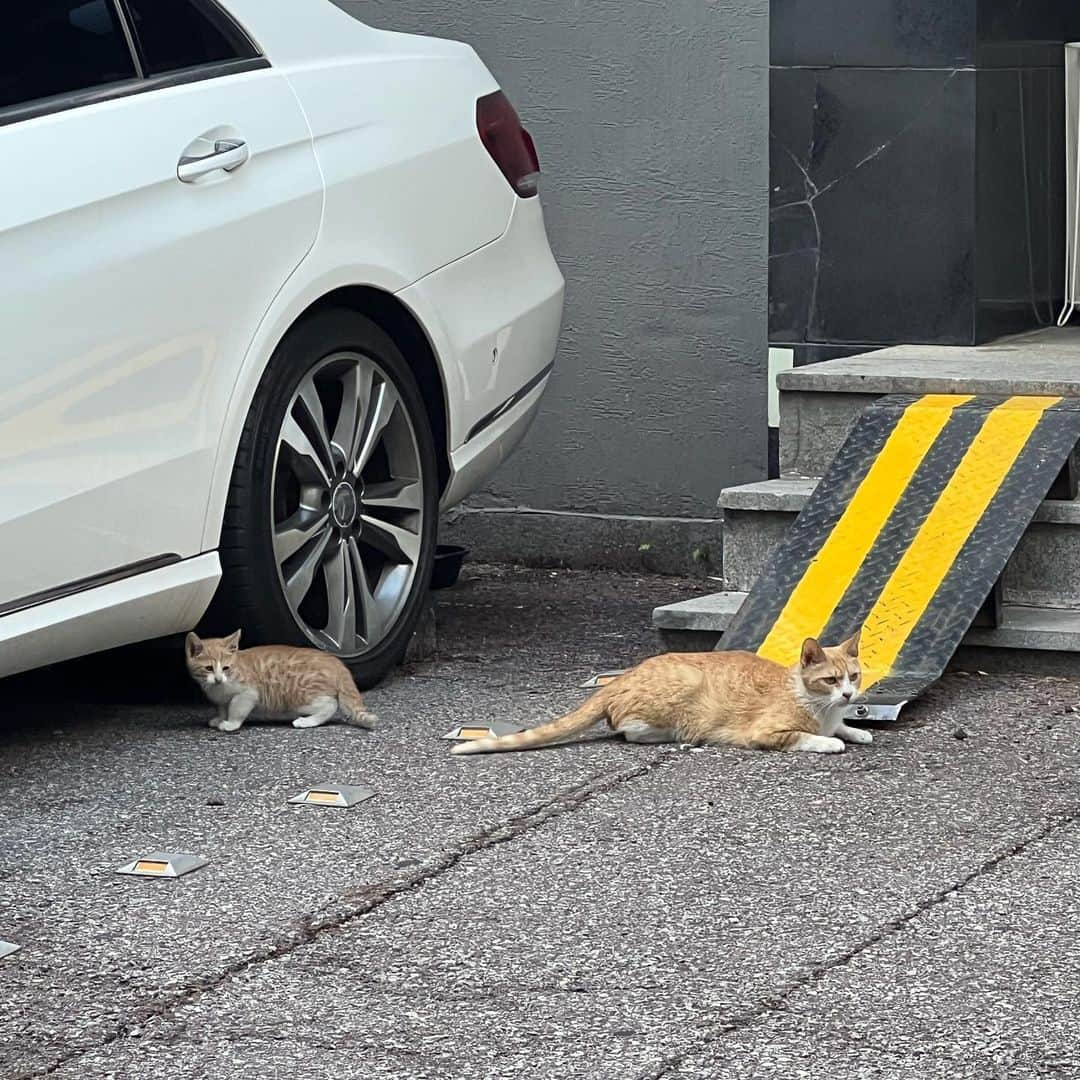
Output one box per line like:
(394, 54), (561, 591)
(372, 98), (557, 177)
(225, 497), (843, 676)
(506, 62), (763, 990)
(852, 397), (1061, 690)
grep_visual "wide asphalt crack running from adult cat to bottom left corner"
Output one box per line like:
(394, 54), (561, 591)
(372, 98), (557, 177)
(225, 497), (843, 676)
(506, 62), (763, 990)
(23, 754), (675, 1080)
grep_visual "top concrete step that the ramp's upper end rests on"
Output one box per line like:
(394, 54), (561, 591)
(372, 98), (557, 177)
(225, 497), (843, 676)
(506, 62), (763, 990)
(777, 326), (1080, 476)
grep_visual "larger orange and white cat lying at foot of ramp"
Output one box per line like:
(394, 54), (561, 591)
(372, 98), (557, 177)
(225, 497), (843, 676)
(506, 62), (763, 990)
(453, 634), (874, 754)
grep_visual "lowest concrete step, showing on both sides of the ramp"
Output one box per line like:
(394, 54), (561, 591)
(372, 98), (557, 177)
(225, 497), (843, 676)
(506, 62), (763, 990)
(652, 592), (1080, 673)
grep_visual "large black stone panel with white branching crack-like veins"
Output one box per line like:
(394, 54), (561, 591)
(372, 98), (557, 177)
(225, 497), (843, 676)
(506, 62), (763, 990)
(769, 68), (975, 345)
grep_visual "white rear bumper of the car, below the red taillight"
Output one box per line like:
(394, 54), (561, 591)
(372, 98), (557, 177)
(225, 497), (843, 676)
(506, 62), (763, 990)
(399, 199), (565, 507)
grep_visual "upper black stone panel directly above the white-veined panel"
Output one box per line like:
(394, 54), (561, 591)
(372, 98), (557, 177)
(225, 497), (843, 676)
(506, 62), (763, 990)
(769, 0), (976, 67)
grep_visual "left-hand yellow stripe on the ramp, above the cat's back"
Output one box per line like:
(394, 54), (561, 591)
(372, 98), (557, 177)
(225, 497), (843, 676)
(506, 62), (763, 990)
(757, 394), (972, 667)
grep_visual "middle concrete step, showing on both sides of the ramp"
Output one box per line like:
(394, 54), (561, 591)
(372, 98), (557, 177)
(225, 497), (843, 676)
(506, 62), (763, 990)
(719, 477), (1080, 610)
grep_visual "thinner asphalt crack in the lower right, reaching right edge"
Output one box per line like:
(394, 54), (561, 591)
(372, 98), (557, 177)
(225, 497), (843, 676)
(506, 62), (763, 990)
(635, 808), (1080, 1080)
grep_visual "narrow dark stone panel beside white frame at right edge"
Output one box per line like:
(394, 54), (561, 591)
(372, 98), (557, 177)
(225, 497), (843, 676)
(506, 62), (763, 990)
(976, 68), (1065, 341)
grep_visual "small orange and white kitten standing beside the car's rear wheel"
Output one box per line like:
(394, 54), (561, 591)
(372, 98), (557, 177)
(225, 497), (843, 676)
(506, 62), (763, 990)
(185, 630), (375, 731)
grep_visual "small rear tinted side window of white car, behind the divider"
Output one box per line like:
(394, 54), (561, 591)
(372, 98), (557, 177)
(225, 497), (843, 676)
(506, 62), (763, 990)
(124, 0), (258, 76)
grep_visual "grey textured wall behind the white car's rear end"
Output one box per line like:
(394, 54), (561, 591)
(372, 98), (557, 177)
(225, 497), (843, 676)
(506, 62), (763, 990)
(339, 0), (769, 570)
